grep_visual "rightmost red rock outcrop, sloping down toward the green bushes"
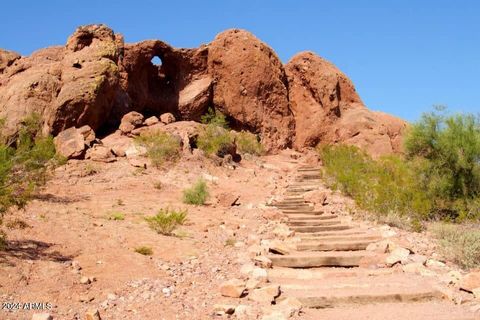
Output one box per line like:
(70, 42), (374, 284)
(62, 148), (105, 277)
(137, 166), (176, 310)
(285, 52), (406, 156)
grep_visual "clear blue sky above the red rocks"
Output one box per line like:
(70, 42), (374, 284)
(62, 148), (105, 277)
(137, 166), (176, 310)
(0, 0), (480, 121)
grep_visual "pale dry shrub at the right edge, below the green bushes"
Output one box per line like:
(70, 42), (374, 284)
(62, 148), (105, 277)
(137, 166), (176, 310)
(430, 223), (480, 269)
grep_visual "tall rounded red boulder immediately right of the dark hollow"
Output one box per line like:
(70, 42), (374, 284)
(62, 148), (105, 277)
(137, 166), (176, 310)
(208, 29), (294, 151)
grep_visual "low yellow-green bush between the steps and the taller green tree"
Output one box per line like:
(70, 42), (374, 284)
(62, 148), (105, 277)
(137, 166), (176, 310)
(320, 145), (432, 225)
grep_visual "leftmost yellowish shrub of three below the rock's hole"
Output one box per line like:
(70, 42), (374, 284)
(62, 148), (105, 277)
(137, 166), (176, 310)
(135, 131), (180, 167)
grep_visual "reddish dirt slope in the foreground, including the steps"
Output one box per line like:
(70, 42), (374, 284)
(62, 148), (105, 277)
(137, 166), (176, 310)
(0, 152), (478, 320)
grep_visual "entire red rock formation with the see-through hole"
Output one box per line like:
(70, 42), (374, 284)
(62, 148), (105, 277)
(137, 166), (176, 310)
(0, 25), (406, 156)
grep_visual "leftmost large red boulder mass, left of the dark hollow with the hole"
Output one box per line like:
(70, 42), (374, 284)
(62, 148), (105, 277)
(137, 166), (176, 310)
(0, 25), (121, 135)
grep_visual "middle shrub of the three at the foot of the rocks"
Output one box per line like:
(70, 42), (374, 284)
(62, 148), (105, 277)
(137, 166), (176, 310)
(197, 124), (234, 156)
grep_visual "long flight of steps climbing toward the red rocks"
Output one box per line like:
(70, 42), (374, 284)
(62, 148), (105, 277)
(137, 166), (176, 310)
(268, 167), (474, 320)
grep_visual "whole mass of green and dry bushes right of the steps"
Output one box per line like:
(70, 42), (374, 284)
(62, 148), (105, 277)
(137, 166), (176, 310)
(319, 108), (480, 268)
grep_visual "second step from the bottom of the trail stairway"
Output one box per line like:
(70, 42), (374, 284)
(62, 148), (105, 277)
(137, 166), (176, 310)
(268, 251), (373, 268)
